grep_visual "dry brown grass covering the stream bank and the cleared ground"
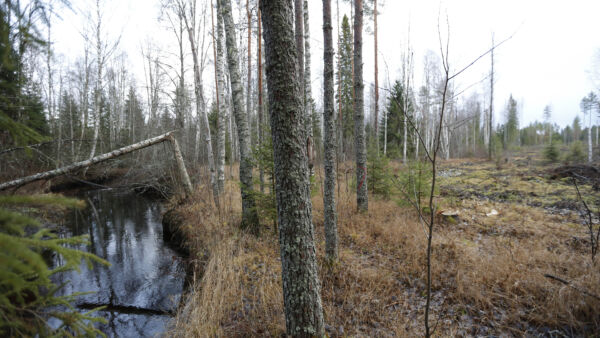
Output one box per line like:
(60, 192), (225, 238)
(169, 152), (600, 337)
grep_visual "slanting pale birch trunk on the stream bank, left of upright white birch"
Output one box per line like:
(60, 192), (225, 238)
(183, 5), (220, 207)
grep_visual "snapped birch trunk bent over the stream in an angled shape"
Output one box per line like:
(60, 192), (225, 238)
(0, 131), (192, 196)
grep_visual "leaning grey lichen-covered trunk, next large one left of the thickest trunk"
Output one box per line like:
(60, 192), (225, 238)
(218, 0), (259, 233)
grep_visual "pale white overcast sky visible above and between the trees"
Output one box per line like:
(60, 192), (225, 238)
(53, 0), (600, 126)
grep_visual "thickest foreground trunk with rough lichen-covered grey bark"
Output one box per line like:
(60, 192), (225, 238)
(260, 0), (324, 337)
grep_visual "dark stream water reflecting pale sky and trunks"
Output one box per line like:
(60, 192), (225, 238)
(55, 190), (185, 337)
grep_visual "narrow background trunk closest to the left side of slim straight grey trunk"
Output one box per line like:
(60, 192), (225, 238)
(303, 0), (315, 176)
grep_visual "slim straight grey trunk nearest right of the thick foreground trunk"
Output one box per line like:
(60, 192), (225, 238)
(323, 0), (338, 260)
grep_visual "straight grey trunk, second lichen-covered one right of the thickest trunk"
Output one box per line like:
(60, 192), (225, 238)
(354, 0), (369, 211)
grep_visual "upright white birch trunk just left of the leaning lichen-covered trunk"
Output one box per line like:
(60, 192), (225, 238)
(211, 2), (229, 192)
